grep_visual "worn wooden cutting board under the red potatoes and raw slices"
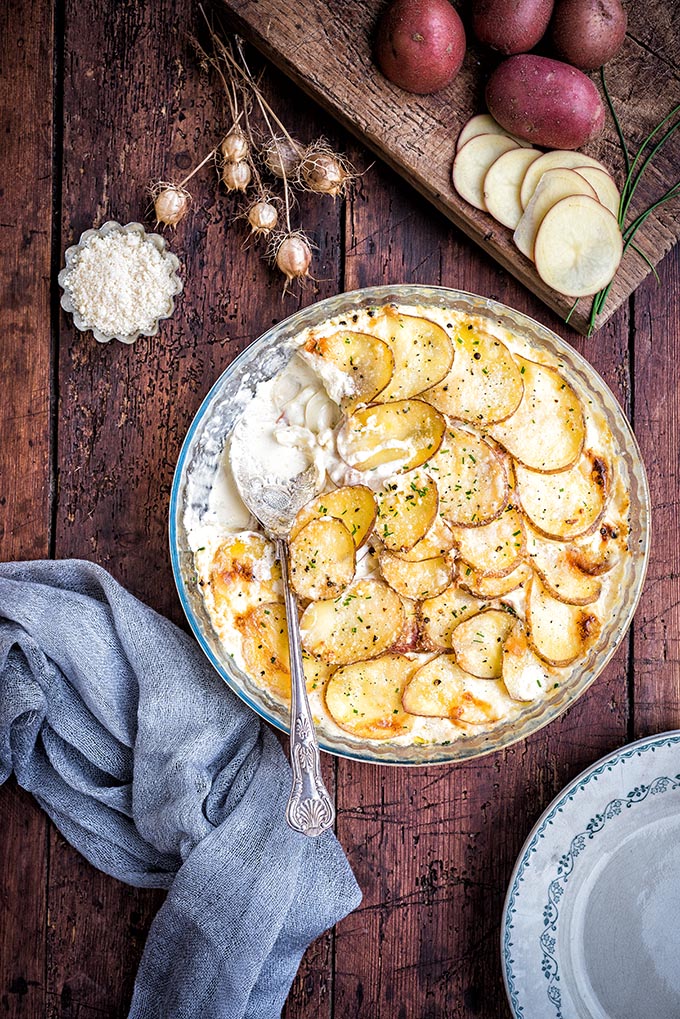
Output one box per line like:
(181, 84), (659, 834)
(224, 0), (680, 333)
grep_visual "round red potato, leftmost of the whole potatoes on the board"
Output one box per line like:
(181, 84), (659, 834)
(375, 0), (465, 95)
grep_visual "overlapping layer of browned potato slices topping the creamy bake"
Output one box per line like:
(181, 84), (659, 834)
(212, 309), (619, 740)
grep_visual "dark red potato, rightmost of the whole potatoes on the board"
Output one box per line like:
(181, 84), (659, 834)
(551, 0), (628, 70)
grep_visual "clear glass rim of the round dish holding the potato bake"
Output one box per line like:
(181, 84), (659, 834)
(169, 285), (649, 765)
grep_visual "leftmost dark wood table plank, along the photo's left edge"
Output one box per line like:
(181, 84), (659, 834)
(0, 2), (54, 1019)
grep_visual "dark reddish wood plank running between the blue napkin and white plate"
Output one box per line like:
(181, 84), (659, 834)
(334, 147), (629, 1019)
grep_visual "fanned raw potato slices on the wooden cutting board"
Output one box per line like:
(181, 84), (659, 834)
(453, 113), (623, 298)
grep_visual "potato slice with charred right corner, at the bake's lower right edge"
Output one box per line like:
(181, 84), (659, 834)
(526, 576), (601, 666)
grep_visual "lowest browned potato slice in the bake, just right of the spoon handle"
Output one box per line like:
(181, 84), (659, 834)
(326, 654), (417, 740)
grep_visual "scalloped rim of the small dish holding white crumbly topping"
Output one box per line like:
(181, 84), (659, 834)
(57, 220), (184, 344)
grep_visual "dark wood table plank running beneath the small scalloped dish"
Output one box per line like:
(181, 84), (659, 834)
(49, 0), (342, 1019)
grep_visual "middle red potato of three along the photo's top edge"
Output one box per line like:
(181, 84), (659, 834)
(472, 0), (555, 55)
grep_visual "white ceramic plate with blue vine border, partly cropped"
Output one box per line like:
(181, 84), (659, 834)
(501, 732), (680, 1019)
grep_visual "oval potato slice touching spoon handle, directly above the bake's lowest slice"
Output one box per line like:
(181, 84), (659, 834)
(300, 580), (404, 665)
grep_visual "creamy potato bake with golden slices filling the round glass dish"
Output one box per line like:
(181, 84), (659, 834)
(188, 306), (629, 744)
